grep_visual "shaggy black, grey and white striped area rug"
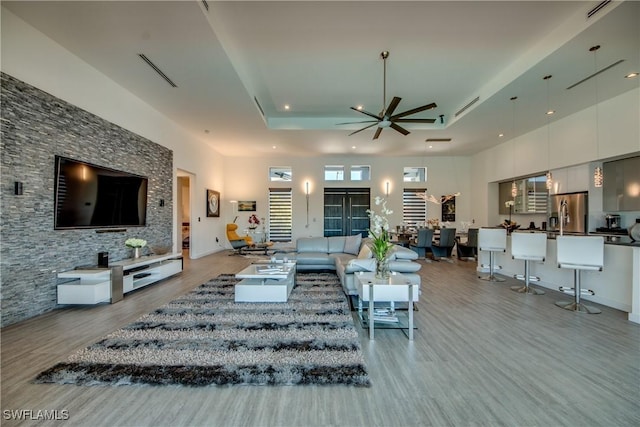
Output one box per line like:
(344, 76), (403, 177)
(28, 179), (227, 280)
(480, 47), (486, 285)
(35, 273), (371, 386)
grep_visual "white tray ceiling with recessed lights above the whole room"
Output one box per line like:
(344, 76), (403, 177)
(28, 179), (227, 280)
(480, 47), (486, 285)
(2, 0), (640, 156)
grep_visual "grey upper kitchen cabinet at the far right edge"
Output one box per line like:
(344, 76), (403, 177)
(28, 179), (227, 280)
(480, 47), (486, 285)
(602, 156), (640, 212)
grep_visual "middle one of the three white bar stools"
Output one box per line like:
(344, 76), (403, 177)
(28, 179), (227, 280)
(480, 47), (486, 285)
(511, 231), (547, 295)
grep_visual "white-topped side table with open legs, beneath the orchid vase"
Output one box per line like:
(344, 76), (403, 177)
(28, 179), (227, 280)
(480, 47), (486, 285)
(355, 272), (419, 341)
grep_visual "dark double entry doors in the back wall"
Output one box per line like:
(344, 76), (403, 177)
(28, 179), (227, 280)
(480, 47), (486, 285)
(324, 188), (371, 237)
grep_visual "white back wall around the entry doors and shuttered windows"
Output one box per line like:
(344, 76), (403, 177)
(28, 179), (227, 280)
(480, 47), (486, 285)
(221, 156), (476, 239)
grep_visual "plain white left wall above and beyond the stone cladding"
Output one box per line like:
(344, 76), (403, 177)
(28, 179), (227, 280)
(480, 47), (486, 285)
(1, 8), (225, 258)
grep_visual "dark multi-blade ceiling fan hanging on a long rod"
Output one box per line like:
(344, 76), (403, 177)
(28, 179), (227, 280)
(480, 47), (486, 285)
(338, 50), (437, 139)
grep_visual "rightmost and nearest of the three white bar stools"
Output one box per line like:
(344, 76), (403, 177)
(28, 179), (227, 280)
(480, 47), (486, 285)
(556, 236), (604, 314)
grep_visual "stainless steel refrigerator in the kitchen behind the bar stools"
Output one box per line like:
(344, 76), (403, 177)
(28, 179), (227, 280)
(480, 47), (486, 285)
(548, 191), (589, 234)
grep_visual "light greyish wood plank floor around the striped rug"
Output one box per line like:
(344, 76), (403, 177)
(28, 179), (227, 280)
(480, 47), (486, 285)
(0, 252), (640, 426)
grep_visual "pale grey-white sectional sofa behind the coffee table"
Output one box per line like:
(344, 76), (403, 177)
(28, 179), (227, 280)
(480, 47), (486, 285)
(277, 235), (422, 295)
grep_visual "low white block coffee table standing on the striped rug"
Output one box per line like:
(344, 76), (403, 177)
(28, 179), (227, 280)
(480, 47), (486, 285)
(235, 262), (296, 302)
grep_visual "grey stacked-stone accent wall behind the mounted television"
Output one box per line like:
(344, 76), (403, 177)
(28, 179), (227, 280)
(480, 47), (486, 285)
(0, 73), (173, 326)
